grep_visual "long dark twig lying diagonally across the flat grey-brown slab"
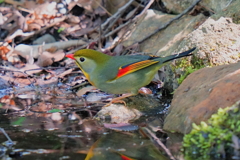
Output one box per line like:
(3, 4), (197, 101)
(137, 0), (201, 43)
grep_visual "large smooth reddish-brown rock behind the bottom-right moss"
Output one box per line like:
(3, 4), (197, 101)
(164, 62), (240, 133)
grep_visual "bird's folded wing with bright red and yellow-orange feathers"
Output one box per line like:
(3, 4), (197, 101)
(110, 59), (159, 81)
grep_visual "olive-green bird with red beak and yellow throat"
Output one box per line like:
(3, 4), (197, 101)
(66, 47), (196, 104)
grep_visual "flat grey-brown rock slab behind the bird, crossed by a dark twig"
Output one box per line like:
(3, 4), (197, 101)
(123, 9), (207, 56)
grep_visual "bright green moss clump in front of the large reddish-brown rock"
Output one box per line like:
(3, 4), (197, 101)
(183, 101), (240, 160)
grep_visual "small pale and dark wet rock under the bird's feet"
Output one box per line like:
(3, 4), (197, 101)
(96, 94), (166, 123)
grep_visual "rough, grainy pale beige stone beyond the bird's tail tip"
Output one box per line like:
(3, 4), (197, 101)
(179, 17), (240, 66)
